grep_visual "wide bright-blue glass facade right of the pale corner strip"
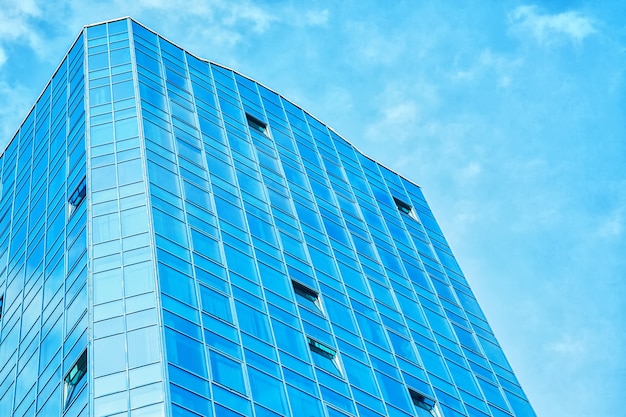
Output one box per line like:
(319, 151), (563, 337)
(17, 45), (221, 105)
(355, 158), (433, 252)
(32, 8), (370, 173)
(124, 18), (534, 416)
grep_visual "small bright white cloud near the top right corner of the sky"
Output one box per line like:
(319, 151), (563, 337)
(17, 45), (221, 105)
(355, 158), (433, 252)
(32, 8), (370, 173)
(509, 6), (596, 45)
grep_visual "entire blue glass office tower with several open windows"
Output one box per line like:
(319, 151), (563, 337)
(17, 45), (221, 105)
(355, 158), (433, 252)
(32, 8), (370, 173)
(0, 19), (535, 417)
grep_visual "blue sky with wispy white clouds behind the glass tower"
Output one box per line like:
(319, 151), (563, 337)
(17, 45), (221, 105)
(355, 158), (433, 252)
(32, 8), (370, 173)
(0, 0), (626, 417)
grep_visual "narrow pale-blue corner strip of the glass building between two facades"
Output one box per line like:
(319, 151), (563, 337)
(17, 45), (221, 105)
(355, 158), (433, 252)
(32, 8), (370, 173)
(86, 20), (166, 416)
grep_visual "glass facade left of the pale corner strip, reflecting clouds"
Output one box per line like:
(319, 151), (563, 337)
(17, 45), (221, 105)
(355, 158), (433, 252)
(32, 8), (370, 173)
(0, 30), (88, 416)
